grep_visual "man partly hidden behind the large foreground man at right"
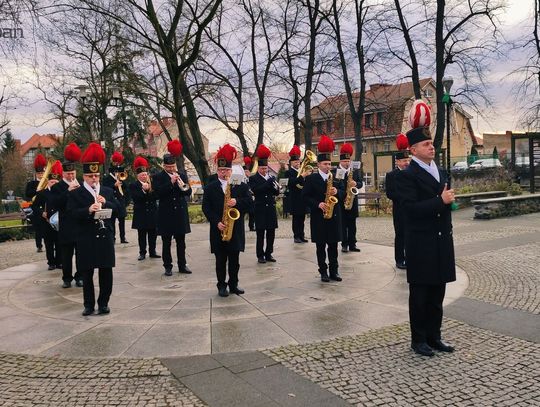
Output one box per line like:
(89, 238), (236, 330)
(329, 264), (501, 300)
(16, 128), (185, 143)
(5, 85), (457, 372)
(385, 147), (409, 270)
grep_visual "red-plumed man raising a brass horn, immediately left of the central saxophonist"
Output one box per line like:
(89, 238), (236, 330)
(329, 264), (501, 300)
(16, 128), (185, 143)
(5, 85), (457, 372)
(152, 140), (191, 276)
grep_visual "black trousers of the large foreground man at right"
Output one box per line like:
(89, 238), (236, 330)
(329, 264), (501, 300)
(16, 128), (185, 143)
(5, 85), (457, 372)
(409, 284), (446, 343)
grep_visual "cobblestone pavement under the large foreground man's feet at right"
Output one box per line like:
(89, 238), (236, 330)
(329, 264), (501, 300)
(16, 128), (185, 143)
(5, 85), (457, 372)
(265, 320), (540, 406)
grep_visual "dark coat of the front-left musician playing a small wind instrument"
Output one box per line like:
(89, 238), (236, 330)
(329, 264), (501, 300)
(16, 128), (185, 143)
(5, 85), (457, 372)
(67, 185), (119, 270)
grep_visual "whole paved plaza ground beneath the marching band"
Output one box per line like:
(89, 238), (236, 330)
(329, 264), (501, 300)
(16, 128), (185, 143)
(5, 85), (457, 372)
(0, 209), (540, 406)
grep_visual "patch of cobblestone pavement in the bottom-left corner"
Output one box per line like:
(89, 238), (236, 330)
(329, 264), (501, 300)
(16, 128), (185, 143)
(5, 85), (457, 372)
(0, 353), (205, 407)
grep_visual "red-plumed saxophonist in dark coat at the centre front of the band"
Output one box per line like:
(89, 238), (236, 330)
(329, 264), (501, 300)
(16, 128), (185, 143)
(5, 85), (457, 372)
(202, 144), (253, 297)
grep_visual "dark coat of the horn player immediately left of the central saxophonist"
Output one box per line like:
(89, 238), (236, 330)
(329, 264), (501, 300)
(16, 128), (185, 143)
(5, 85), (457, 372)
(152, 171), (191, 235)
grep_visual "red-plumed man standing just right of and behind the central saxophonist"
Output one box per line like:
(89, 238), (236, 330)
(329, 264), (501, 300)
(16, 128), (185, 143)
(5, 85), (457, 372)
(249, 144), (279, 263)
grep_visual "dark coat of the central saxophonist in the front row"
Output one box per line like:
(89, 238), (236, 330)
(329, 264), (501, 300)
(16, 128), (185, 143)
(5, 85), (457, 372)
(202, 180), (253, 253)
